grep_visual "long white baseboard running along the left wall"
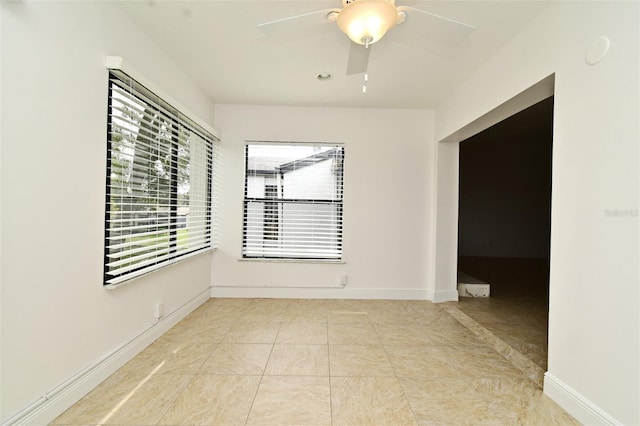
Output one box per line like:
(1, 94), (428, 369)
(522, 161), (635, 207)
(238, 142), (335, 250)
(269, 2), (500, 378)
(2, 288), (211, 426)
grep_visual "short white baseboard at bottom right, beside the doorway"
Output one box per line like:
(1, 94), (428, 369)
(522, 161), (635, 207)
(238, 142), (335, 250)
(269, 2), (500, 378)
(544, 372), (622, 425)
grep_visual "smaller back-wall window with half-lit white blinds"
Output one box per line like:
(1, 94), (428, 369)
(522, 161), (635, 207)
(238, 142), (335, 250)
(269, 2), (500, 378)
(242, 142), (344, 261)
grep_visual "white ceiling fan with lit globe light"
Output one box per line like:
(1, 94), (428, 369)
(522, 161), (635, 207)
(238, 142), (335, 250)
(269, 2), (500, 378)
(258, 0), (475, 76)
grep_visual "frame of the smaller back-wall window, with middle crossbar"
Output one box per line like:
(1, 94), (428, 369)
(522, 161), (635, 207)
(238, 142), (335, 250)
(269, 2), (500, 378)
(240, 140), (345, 263)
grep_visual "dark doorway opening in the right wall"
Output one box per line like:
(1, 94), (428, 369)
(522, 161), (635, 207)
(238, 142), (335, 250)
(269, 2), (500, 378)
(458, 96), (553, 371)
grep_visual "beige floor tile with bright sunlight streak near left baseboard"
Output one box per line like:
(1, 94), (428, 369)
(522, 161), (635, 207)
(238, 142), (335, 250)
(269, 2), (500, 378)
(52, 373), (193, 425)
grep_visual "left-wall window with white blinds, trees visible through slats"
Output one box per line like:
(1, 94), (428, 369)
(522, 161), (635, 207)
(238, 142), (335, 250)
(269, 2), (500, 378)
(104, 71), (217, 285)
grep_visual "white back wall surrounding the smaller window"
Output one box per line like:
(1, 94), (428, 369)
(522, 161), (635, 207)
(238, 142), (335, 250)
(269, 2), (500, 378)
(213, 105), (435, 298)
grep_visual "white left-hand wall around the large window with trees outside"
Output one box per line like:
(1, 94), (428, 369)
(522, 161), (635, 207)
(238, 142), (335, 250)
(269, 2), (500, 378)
(0, 2), (214, 422)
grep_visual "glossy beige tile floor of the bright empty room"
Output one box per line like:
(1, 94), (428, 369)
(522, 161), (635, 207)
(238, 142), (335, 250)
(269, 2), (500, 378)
(52, 299), (577, 426)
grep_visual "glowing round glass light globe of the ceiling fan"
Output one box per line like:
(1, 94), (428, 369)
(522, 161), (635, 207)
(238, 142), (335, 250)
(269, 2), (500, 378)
(337, 0), (398, 45)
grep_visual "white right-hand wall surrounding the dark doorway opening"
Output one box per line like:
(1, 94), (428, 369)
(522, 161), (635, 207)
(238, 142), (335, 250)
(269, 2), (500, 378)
(436, 1), (640, 424)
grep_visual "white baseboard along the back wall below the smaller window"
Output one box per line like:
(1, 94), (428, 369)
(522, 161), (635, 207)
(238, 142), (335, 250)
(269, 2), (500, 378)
(211, 286), (428, 300)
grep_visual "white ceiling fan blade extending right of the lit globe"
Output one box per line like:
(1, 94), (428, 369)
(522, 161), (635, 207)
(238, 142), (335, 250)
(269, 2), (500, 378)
(394, 6), (475, 47)
